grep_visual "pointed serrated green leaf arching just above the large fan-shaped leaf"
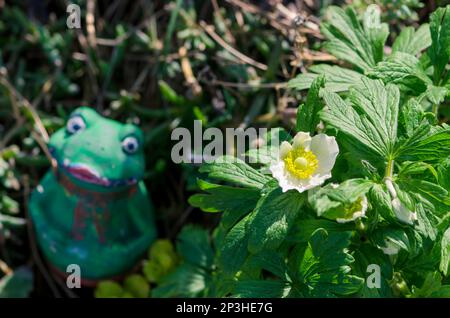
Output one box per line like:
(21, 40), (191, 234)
(367, 52), (431, 95)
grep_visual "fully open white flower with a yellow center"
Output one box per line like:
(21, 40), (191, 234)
(270, 132), (339, 192)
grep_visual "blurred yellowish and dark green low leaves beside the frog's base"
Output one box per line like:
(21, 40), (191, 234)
(95, 225), (215, 298)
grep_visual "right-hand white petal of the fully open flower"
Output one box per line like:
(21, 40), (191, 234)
(311, 134), (339, 174)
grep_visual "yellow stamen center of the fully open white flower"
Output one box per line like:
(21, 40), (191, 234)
(283, 147), (319, 179)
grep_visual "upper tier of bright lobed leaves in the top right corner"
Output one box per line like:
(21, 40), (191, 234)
(289, 5), (450, 113)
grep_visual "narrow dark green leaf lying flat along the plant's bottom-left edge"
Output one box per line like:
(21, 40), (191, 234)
(235, 280), (291, 298)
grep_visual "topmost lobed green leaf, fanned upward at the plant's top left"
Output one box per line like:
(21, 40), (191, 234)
(321, 6), (389, 71)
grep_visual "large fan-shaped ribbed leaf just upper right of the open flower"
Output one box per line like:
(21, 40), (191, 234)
(321, 77), (399, 158)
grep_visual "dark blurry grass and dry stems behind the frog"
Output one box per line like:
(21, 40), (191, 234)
(0, 0), (444, 296)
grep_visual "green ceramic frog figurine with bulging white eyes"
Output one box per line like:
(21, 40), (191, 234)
(29, 107), (156, 285)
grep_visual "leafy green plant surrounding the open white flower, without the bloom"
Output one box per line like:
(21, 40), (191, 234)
(190, 21), (450, 297)
